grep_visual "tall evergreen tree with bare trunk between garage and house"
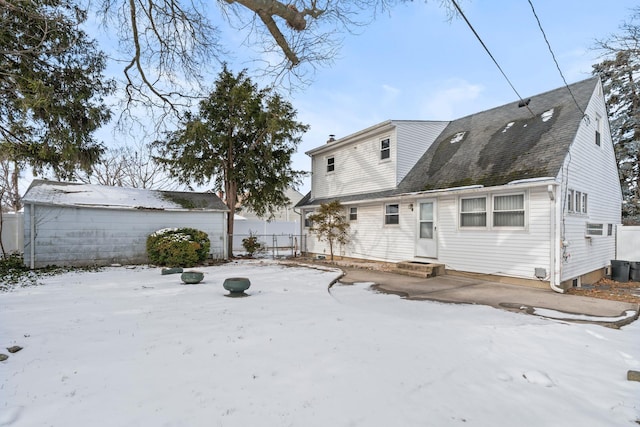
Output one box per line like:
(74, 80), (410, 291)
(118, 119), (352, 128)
(155, 66), (308, 254)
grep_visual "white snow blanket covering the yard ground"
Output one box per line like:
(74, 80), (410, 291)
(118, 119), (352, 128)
(0, 261), (640, 427)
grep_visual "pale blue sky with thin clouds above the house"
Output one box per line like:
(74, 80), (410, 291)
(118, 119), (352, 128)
(25, 0), (640, 194)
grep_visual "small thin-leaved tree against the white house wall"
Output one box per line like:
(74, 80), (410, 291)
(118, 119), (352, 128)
(308, 200), (349, 261)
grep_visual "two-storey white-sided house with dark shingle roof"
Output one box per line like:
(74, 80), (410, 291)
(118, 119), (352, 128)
(298, 78), (622, 291)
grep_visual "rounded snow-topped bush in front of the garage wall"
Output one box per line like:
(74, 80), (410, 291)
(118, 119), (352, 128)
(147, 228), (211, 267)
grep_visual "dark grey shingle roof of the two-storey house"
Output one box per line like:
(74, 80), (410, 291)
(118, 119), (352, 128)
(297, 78), (599, 206)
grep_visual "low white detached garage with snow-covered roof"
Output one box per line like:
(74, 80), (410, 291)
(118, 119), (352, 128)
(23, 180), (228, 268)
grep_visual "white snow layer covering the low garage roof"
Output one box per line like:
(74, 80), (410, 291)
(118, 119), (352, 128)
(23, 181), (224, 210)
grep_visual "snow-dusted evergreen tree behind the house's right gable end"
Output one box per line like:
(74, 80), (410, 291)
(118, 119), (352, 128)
(593, 8), (640, 223)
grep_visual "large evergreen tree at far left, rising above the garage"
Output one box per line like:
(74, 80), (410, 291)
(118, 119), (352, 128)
(0, 0), (113, 178)
